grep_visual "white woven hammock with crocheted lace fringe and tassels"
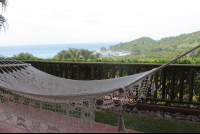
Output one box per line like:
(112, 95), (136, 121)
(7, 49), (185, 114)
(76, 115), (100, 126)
(0, 46), (200, 132)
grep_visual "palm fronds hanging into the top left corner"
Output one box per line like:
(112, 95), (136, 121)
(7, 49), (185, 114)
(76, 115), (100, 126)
(0, 0), (8, 30)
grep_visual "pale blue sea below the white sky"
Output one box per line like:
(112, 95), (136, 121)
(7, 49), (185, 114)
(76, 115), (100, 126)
(0, 42), (123, 58)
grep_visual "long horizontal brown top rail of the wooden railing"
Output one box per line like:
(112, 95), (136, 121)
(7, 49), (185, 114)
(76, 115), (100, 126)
(22, 60), (200, 67)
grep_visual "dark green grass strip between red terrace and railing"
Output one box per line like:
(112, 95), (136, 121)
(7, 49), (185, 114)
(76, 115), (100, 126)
(95, 111), (200, 133)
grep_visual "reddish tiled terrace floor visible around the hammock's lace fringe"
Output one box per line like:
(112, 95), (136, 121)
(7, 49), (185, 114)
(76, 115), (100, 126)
(0, 118), (141, 133)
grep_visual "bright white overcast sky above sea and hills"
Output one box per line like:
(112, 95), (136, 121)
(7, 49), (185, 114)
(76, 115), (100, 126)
(0, 0), (200, 46)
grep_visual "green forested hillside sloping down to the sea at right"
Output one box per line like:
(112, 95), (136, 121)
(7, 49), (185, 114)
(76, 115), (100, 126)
(109, 31), (200, 59)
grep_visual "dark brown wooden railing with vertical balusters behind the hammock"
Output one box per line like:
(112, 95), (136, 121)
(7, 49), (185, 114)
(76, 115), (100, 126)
(24, 61), (200, 108)
